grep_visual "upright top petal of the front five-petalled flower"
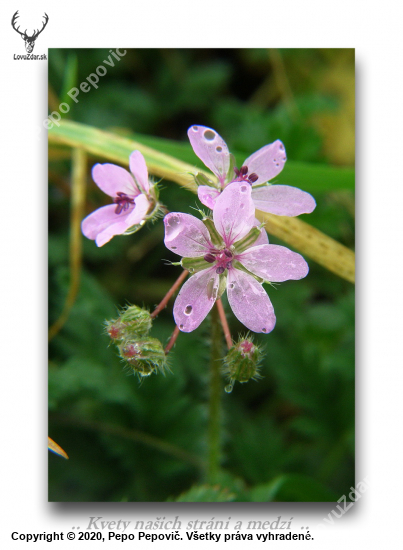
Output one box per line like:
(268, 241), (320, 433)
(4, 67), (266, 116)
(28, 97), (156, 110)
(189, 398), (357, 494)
(213, 181), (255, 246)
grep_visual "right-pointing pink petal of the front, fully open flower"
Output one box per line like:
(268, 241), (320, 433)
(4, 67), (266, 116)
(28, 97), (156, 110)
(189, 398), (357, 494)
(236, 244), (309, 283)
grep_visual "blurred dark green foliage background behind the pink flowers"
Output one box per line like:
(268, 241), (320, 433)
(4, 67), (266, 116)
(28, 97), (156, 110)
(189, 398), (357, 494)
(49, 49), (354, 501)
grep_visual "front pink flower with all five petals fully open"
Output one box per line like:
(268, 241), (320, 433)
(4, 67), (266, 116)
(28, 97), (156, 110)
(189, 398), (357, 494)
(164, 181), (308, 333)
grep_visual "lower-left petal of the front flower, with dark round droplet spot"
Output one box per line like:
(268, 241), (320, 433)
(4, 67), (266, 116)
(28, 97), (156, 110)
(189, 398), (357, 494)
(174, 267), (219, 332)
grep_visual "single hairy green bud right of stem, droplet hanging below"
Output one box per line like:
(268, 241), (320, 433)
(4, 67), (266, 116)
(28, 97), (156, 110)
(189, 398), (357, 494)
(223, 337), (262, 393)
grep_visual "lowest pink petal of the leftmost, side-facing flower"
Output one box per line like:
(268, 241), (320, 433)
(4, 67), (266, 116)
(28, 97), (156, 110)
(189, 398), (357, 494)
(81, 204), (134, 246)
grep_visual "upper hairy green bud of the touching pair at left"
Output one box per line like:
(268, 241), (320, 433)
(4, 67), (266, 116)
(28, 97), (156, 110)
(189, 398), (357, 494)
(106, 306), (152, 340)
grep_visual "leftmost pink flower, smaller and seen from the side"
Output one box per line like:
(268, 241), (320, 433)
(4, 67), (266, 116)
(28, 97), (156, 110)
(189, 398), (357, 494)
(81, 151), (156, 246)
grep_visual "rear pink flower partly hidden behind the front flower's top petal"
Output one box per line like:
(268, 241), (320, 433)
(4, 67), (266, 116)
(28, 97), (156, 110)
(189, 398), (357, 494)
(188, 126), (316, 216)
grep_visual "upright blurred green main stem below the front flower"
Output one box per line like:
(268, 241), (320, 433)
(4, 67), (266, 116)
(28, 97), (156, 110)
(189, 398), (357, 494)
(207, 306), (222, 484)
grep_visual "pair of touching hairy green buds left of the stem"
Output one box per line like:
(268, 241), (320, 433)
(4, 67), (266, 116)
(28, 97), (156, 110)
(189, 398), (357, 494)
(106, 306), (166, 377)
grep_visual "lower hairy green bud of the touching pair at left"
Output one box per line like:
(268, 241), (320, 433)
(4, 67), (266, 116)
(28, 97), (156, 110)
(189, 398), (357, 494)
(118, 337), (166, 377)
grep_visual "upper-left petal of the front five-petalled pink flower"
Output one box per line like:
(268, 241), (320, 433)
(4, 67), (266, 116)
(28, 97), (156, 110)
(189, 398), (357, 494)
(164, 212), (211, 258)
